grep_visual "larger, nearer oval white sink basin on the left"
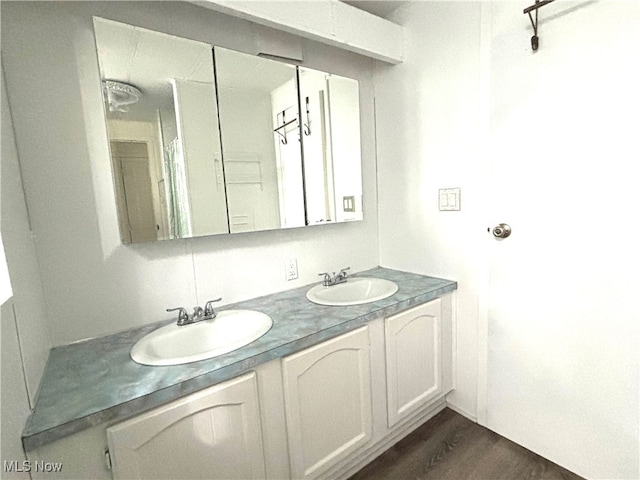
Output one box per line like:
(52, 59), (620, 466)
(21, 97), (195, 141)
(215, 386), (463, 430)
(131, 310), (273, 365)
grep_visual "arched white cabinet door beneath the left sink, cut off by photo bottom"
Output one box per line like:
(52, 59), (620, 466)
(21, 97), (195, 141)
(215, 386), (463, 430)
(107, 372), (265, 479)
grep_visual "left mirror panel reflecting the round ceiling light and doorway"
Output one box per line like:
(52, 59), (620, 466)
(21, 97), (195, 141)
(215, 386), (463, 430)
(94, 18), (229, 243)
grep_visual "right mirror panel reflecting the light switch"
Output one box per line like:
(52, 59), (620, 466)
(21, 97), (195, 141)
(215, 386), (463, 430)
(299, 67), (362, 225)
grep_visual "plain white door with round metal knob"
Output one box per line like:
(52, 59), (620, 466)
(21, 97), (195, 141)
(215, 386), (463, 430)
(480, 2), (640, 479)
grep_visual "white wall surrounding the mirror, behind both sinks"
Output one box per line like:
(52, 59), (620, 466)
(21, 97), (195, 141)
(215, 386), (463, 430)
(2, 2), (378, 345)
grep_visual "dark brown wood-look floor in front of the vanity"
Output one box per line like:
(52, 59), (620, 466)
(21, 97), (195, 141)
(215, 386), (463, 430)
(350, 408), (582, 480)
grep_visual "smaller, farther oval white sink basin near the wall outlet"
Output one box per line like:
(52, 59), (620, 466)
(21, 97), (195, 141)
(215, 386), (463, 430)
(307, 277), (398, 306)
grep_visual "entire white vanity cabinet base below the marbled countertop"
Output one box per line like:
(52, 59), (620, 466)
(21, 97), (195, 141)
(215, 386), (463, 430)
(28, 295), (454, 480)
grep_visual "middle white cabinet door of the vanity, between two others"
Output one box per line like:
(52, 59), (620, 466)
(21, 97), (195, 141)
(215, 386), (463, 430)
(283, 327), (372, 478)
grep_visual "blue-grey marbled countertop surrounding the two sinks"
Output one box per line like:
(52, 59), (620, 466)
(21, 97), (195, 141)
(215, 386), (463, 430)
(23, 268), (457, 450)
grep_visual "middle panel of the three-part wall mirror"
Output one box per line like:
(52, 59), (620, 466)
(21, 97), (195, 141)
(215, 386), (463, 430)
(214, 47), (305, 233)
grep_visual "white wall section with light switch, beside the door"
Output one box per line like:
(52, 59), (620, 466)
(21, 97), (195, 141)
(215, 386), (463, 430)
(375, 2), (486, 418)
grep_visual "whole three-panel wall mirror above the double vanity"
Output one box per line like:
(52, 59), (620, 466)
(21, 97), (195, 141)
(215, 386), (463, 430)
(94, 18), (362, 243)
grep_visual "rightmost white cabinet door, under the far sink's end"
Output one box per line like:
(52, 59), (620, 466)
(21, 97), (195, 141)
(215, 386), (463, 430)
(385, 299), (442, 427)
